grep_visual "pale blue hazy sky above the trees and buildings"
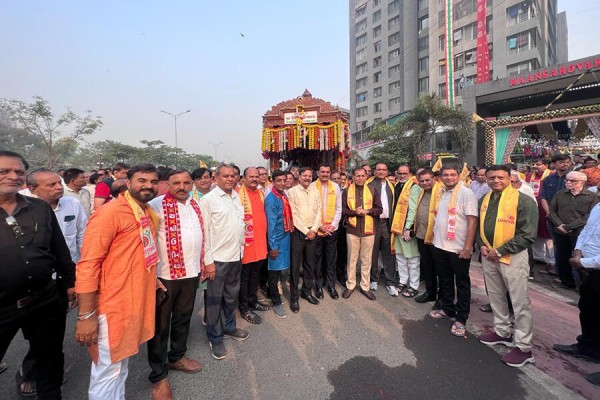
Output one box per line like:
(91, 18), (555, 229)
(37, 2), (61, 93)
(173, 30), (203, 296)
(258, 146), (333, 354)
(0, 0), (600, 167)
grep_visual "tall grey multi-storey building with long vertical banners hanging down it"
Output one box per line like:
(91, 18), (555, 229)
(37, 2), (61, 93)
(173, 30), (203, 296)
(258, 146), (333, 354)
(349, 0), (566, 156)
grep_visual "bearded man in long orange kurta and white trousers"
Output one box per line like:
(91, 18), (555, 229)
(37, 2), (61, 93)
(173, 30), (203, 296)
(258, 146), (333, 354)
(75, 164), (158, 400)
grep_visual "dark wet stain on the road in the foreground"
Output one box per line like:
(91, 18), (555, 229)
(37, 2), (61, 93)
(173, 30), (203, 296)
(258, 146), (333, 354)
(328, 318), (526, 400)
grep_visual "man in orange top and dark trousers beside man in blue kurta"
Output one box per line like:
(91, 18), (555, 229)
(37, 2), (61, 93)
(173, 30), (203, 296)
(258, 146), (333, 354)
(238, 167), (271, 324)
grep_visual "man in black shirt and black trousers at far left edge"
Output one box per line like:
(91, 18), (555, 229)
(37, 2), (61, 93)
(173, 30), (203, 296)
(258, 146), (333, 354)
(0, 151), (75, 400)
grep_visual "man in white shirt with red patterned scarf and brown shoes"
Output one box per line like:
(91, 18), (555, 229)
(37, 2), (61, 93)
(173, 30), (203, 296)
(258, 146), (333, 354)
(148, 169), (204, 399)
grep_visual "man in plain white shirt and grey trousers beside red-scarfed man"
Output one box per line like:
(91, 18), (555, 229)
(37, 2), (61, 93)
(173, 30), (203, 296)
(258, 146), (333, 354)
(200, 164), (248, 360)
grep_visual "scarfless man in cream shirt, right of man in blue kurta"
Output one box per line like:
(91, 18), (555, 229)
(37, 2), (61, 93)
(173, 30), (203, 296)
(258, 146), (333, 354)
(288, 167), (321, 312)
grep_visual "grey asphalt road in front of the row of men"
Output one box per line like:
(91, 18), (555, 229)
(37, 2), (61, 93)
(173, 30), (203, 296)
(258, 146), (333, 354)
(0, 264), (587, 400)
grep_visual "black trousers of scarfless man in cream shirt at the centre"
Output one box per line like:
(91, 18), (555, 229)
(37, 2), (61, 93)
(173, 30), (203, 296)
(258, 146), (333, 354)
(290, 230), (317, 303)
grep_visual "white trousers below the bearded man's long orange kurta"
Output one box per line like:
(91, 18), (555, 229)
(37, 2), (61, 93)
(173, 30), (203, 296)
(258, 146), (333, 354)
(88, 315), (129, 400)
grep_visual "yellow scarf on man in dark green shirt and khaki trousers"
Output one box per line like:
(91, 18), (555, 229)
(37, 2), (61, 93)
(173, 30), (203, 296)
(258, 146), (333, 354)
(479, 185), (519, 265)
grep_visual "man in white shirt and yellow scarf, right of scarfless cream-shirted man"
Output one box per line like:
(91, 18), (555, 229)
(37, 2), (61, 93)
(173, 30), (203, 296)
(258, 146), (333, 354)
(311, 164), (342, 300)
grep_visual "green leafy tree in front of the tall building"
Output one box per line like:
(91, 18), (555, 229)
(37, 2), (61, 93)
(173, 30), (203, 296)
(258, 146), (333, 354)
(369, 93), (474, 166)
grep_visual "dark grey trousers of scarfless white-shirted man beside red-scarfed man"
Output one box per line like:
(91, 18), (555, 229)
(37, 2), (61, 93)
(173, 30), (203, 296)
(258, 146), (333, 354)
(204, 260), (242, 343)
